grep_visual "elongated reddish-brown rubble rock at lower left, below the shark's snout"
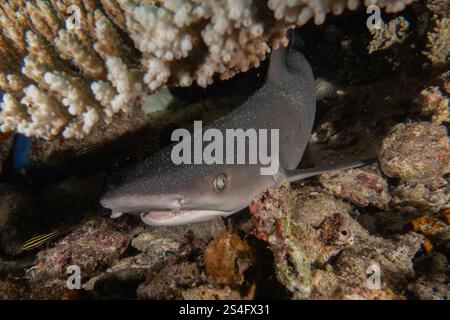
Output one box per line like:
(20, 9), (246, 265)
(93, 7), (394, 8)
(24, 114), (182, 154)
(28, 219), (129, 299)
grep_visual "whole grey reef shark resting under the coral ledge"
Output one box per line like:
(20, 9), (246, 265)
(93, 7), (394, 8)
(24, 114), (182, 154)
(100, 30), (364, 226)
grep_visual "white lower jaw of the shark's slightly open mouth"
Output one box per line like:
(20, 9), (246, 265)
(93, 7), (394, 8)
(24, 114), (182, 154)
(140, 210), (234, 226)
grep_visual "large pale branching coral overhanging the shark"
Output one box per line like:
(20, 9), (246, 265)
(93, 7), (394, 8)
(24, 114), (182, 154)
(0, 0), (413, 139)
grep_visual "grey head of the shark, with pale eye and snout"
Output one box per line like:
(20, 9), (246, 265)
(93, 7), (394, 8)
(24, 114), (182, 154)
(101, 154), (271, 226)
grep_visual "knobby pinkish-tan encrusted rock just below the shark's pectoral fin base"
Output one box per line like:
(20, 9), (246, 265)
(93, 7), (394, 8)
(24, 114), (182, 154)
(251, 186), (353, 299)
